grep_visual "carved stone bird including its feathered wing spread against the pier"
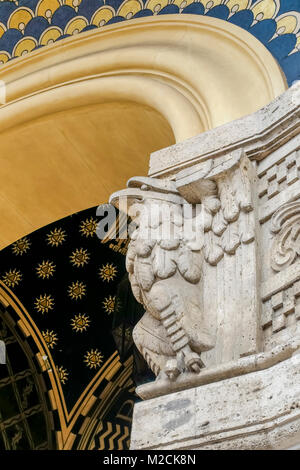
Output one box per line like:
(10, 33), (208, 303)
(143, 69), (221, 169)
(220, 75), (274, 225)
(110, 151), (253, 380)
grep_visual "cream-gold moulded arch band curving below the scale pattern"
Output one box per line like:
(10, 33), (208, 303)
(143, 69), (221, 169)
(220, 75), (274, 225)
(0, 15), (287, 142)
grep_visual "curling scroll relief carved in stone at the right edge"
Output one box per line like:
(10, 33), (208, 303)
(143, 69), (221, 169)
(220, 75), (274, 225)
(271, 201), (300, 271)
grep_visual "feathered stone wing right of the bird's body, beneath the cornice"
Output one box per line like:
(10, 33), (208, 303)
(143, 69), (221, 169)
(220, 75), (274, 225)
(176, 151), (255, 265)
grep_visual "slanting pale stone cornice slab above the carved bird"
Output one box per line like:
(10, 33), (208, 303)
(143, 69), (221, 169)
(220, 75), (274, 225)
(149, 82), (300, 178)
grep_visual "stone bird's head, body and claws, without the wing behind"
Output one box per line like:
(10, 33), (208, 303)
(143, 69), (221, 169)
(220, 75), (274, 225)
(111, 178), (213, 379)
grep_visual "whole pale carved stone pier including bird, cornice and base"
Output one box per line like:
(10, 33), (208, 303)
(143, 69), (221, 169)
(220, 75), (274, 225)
(111, 83), (300, 449)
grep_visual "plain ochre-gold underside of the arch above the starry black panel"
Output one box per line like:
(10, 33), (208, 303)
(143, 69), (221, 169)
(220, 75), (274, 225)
(0, 102), (175, 249)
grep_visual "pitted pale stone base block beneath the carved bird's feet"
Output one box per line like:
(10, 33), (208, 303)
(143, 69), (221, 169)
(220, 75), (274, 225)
(131, 351), (300, 450)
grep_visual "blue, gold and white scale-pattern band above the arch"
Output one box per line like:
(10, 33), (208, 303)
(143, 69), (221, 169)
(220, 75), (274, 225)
(0, 0), (300, 85)
